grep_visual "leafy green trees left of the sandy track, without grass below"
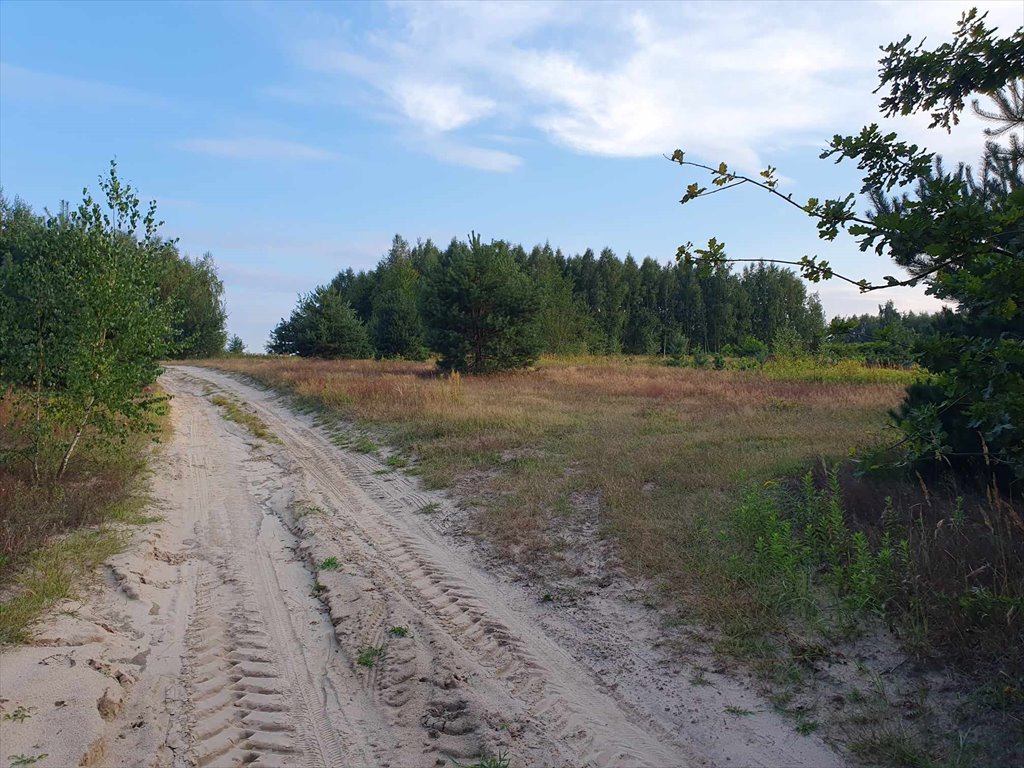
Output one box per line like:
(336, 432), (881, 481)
(0, 163), (227, 481)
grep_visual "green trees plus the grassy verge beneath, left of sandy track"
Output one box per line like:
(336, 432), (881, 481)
(0, 164), (226, 643)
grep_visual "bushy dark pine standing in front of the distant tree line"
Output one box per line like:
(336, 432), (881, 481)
(423, 233), (541, 374)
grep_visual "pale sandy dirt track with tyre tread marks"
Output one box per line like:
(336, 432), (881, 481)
(0, 368), (843, 768)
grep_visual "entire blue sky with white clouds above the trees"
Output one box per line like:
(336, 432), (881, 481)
(0, 0), (1024, 350)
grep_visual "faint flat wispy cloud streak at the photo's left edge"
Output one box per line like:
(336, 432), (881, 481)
(0, 61), (172, 108)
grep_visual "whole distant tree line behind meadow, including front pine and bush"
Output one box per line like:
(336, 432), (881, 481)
(267, 233), (827, 372)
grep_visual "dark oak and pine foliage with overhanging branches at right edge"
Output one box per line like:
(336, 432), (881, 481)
(673, 10), (1024, 481)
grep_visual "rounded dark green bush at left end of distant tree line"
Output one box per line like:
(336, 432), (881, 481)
(266, 286), (373, 358)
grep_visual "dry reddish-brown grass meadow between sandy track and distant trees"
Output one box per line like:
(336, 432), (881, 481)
(195, 358), (902, 583)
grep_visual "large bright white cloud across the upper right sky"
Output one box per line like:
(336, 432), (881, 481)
(268, 2), (1021, 170)
